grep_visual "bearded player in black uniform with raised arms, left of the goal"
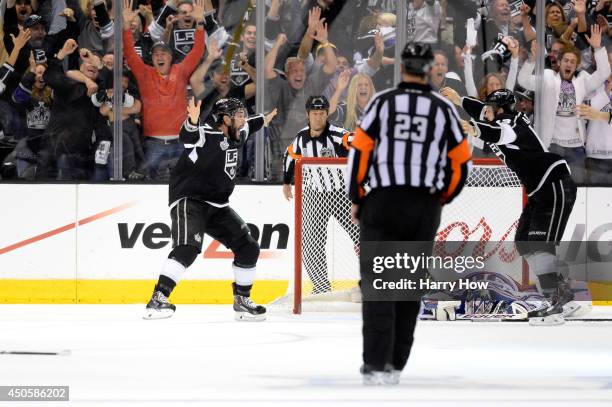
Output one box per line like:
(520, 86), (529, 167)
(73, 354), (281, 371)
(144, 98), (266, 321)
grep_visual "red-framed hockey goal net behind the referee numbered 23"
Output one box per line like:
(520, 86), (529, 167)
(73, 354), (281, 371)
(286, 158), (528, 313)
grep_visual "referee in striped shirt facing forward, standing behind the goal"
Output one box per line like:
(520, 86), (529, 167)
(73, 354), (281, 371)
(283, 96), (359, 294)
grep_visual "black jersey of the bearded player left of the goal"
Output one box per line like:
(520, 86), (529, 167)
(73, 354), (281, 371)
(169, 115), (264, 206)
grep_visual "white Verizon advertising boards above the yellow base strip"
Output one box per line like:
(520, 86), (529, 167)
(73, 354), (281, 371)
(0, 185), (612, 296)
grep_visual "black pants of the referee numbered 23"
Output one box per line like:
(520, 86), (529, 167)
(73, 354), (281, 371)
(359, 187), (442, 371)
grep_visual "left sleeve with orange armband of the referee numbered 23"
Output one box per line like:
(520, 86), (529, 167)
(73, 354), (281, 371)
(346, 127), (374, 204)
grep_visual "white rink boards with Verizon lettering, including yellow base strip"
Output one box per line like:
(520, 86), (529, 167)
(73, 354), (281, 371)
(0, 184), (612, 303)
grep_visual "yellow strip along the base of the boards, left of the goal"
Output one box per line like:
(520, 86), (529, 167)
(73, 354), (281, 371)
(0, 279), (288, 304)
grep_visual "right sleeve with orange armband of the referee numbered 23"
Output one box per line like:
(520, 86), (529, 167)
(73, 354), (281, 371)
(442, 106), (472, 204)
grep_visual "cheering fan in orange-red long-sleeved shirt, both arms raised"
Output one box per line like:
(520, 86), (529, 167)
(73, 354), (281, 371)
(123, 0), (204, 178)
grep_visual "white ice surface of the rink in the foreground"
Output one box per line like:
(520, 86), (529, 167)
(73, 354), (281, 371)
(0, 305), (612, 407)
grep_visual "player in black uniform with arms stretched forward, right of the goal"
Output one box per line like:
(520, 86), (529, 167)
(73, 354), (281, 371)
(441, 88), (580, 325)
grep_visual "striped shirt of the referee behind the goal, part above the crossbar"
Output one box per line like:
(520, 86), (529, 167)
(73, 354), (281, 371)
(283, 123), (352, 185)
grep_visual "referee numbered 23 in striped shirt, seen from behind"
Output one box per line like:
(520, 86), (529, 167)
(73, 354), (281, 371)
(346, 43), (471, 385)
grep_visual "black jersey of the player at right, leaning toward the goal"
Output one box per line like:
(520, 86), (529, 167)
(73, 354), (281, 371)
(461, 97), (570, 195)
